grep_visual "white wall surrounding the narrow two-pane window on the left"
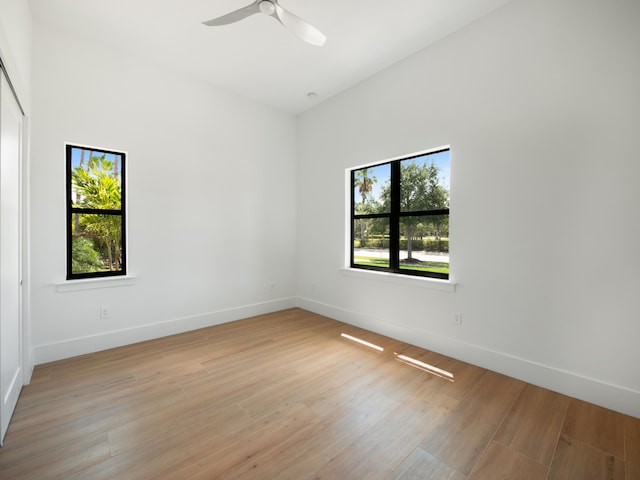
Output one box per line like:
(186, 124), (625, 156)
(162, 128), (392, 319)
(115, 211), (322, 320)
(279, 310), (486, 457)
(31, 23), (296, 363)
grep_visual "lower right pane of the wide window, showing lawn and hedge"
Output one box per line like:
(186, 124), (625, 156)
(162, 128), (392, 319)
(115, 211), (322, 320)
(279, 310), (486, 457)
(400, 215), (449, 274)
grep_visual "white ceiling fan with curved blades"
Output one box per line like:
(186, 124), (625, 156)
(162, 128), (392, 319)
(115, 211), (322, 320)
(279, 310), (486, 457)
(202, 0), (327, 46)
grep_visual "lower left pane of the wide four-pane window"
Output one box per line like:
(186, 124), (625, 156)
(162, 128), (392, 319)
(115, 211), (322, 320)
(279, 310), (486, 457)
(353, 218), (389, 268)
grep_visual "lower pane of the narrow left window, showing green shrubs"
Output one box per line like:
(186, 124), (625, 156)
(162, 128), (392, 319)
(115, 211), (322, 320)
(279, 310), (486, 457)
(71, 213), (123, 274)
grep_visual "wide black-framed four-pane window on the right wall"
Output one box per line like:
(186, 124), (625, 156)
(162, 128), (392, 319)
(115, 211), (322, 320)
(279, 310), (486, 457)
(351, 148), (450, 279)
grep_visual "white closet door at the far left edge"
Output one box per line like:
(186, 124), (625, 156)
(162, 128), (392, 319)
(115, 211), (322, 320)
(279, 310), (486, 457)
(0, 69), (23, 445)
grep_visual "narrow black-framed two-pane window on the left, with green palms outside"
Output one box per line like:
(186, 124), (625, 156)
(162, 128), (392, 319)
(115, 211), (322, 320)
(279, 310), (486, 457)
(66, 145), (127, 280)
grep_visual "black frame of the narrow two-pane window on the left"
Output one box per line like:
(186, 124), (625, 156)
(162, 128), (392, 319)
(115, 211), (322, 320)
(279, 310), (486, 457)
(65, 143), (127, 280)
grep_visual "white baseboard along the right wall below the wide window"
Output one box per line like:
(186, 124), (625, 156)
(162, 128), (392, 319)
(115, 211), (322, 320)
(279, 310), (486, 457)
(296, 297), (640, 418)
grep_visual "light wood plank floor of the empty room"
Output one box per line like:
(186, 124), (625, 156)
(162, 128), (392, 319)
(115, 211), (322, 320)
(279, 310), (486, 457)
(0, 309), (640, 480)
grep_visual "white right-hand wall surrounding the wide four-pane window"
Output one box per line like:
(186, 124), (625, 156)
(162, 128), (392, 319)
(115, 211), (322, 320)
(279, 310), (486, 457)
(298, 0), (640, 417)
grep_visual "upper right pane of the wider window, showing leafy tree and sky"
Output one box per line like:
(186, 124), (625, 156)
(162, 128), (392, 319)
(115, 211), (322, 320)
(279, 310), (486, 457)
(400, 150), (450, 212)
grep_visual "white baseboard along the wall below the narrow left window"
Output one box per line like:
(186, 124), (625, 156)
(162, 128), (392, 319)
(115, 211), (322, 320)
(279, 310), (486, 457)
(32, 297), (296, 365)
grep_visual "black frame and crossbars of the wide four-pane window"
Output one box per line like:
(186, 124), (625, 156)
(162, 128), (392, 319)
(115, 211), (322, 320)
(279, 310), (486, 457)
(349, 147), (451, 280)
